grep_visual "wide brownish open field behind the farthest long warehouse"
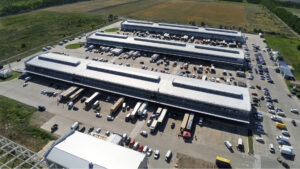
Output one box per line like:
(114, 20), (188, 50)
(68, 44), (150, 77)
(45, 0), (292, 35)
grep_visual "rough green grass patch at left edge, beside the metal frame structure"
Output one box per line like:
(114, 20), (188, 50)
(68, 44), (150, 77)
(0, 96), (55, 152)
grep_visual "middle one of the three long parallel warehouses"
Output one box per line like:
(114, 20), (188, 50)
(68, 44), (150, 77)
(87, 32), (245, 67)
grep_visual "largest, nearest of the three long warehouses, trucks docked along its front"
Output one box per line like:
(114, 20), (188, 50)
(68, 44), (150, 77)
(25, 53), (251, 123)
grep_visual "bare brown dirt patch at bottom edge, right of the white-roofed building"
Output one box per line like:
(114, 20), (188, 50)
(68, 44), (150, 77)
(174, 153), (218, 168)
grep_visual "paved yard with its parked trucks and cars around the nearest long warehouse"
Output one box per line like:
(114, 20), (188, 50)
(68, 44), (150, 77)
(0, 20), (300, 168)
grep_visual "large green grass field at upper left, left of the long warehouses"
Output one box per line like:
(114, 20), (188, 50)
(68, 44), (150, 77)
(0, 11), (105, 60)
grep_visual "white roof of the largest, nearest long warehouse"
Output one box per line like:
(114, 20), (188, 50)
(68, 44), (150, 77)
(25, 53), (251, 121)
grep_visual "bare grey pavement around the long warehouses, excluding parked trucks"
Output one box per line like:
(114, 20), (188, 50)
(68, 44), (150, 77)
(0, 21), (300, 168)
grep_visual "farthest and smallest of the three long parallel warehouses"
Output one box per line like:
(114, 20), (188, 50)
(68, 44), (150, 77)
(121, 20), (245, 43)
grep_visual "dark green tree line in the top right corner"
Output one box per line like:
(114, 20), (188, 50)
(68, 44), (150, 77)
(247, 0), (300, 34)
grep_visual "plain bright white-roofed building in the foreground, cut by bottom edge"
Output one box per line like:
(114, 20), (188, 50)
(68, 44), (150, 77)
(44, 130), (147, 169)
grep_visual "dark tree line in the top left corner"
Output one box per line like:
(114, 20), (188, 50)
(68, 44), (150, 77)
(0, 0), (87, 16)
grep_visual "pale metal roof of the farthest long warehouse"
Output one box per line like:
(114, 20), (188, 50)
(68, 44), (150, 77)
(121, 20), (243, 39)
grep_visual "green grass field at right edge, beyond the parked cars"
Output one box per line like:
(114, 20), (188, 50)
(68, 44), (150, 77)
(265, 35), (300, 80)
